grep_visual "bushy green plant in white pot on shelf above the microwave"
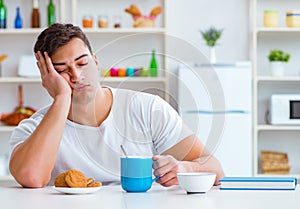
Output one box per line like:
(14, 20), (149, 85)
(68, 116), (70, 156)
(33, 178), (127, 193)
(268, 49), (291, 76)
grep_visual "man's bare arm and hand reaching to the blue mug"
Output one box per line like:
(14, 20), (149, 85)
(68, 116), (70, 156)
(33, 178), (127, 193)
(153, 135), (224, 186)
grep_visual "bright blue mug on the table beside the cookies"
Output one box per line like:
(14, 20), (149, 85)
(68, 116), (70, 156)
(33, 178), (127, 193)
(121, 156), (158, 192)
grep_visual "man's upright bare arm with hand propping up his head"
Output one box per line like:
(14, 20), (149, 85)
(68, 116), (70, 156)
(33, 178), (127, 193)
(9, 52), (71, 187)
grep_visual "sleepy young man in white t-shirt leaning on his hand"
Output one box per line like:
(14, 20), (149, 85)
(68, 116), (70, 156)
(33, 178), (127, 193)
(10, 24), (224, 187)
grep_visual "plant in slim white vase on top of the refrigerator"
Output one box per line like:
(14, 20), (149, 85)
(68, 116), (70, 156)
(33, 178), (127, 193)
(200, 26), (223, 63)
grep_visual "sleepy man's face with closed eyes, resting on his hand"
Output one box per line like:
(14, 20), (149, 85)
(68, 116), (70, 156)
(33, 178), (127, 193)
(51, 38), (100, 104)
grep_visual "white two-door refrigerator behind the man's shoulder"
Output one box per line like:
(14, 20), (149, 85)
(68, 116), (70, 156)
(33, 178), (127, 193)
(178, 61), (253, 176)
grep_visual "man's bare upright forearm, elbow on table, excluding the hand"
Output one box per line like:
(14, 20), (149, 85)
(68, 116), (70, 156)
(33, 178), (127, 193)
(10, 97), (70, 187)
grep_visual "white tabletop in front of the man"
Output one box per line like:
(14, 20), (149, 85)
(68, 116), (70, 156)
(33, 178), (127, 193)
(0, 183), (300, 209)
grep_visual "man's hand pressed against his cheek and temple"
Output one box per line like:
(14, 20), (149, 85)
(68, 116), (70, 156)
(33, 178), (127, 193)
(35, 51), (72, 99)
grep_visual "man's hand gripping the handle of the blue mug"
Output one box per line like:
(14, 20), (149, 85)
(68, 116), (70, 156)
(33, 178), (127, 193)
(152, 155), (185, 187)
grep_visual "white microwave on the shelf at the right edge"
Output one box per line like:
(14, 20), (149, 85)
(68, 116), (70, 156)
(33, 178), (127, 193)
(269, 94), (300, 125)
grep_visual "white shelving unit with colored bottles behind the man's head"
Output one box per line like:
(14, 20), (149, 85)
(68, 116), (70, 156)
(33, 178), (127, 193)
(0, 0), (169, 179)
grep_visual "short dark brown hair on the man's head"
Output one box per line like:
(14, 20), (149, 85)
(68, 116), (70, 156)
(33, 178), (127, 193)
(34, 23), (92, 57)
